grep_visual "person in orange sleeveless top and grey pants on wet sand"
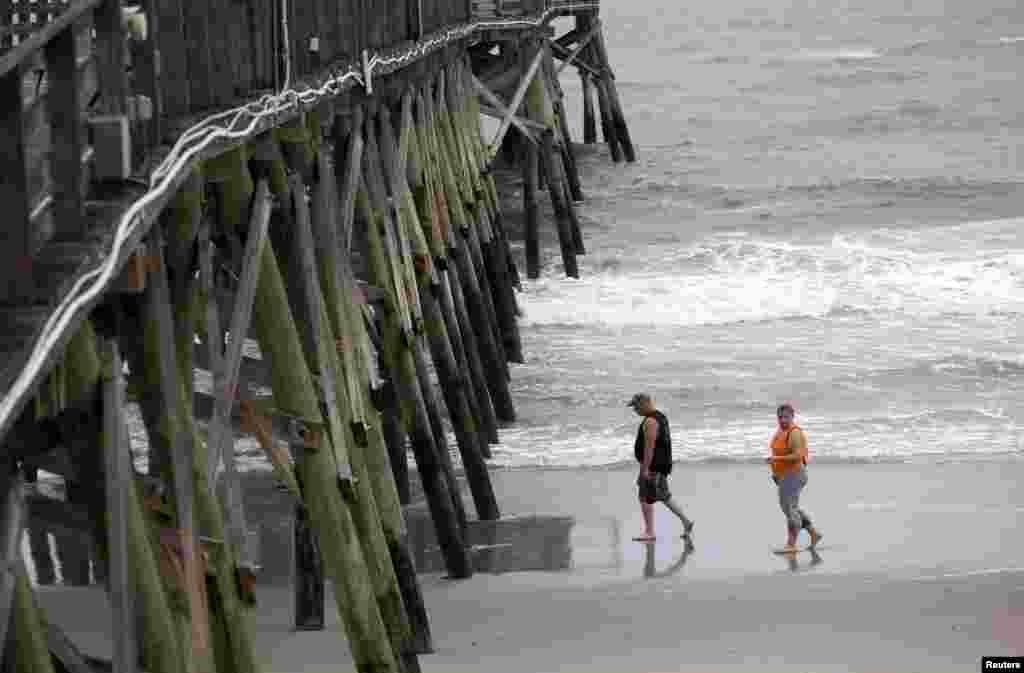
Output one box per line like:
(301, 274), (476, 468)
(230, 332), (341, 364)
(768, 403), (822, 552)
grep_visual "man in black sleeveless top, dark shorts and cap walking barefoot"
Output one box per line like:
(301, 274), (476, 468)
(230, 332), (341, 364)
(627, 392), (693, 542)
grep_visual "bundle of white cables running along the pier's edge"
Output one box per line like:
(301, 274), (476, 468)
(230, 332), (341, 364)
(0, 0), (599, 434)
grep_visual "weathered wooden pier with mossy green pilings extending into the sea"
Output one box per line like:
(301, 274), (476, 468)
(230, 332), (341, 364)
(0, 0), (635, 673)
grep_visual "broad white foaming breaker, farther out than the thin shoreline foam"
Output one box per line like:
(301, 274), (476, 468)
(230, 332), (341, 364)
(520, 218), (1024, 327)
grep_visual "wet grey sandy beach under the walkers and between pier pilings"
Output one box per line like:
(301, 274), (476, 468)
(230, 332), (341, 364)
(29, 460), (1024, 673)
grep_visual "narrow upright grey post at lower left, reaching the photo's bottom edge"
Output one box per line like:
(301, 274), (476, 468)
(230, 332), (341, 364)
(103, 340), (139, 673)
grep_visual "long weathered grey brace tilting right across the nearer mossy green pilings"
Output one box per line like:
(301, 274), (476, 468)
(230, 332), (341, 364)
(208, 180), (270, 495)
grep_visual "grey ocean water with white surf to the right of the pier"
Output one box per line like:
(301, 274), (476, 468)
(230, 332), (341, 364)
(493, 0), (1024, 467)
